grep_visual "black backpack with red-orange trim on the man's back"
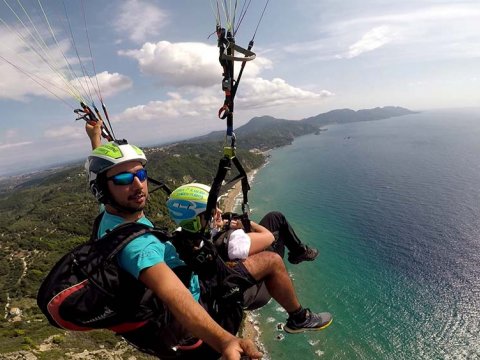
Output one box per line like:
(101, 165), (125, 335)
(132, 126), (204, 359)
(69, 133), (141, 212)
(37, 214), (175, 333)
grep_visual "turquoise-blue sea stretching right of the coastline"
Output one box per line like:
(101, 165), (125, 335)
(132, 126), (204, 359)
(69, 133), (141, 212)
(240, 109), (480, 360)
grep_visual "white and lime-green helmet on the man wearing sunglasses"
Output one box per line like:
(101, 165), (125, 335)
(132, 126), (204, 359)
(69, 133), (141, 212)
(85, 140), (147, 203)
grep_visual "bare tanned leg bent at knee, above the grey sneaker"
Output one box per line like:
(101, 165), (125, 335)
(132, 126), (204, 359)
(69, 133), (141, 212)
(243, 251), (301, 313)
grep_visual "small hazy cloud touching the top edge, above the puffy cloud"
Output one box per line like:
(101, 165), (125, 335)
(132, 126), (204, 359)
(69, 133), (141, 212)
(115, 0), (168, 43)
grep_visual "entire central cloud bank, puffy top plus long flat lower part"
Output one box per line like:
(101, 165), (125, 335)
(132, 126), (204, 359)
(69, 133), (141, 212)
(117, 37), (333, 122)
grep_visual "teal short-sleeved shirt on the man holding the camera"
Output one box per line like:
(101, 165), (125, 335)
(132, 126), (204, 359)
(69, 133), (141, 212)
(98, 211), (200, 301)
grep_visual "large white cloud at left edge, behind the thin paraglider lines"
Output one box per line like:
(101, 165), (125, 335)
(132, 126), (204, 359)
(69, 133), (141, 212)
(0, 28), (132, 101)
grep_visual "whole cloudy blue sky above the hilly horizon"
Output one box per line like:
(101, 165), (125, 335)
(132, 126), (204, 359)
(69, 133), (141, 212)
(0, 0), (480, 176)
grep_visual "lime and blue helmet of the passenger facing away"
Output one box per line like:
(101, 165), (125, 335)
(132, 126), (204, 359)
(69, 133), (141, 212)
(167, 183), (210, 232)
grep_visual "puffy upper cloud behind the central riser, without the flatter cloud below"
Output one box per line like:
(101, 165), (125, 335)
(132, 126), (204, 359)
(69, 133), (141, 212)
(119, 41), (272, 87)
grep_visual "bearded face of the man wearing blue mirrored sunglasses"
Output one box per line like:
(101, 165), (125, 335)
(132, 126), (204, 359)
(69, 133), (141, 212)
(106, 161), (148, 212)
